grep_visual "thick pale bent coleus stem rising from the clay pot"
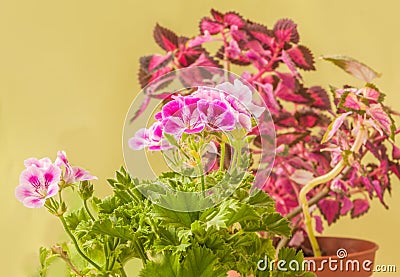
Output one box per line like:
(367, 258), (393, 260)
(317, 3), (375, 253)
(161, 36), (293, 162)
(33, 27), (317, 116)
(299, 127), (367, 257)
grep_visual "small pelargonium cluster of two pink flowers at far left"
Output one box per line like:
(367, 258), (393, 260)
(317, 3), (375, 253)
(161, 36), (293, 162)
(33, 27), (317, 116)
(15, 151), (97, 208)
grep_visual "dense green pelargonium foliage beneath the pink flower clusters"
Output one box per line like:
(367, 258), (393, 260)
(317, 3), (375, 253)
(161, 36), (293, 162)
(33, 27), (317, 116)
(36, 168), (312, 277)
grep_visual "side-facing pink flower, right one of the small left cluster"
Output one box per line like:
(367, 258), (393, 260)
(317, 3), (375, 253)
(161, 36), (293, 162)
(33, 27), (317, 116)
(54, 151), (97, 185)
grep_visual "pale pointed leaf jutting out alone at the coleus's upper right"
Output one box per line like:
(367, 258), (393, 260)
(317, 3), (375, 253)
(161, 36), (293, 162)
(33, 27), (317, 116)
(322, 55), (381, 83)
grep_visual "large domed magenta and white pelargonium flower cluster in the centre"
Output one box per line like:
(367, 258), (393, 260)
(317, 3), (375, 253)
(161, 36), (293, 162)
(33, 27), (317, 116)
(129, 80), (265, 150)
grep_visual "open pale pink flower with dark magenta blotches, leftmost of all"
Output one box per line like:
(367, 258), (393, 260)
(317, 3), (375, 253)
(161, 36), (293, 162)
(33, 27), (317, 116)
(15, 164), (61, 208)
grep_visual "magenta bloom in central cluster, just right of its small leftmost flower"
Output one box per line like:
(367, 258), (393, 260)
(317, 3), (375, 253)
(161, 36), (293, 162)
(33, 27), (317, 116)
(161, 95), (205, 137)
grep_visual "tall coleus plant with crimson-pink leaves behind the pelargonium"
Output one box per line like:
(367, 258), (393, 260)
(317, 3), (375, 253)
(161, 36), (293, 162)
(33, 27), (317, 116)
(137, 10), (400, 255)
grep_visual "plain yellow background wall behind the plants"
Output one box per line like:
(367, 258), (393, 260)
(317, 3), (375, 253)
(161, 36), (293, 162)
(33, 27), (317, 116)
(0, 0), (400, 277)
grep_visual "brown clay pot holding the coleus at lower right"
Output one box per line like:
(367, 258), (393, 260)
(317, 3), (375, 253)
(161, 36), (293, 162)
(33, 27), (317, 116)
(304, 237), (378, 277)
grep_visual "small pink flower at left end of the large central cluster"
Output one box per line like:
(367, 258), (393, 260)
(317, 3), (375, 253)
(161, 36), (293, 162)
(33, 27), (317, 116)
(128, 121), (172, 150)
